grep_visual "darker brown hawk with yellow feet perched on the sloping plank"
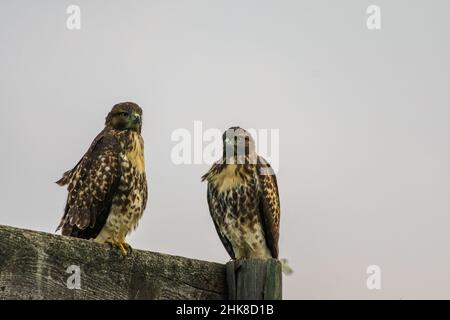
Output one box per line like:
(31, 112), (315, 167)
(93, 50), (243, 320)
(57, 102), (147, 255)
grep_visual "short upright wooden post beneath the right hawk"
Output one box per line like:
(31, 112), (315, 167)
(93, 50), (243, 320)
(227, 259), (282, 300)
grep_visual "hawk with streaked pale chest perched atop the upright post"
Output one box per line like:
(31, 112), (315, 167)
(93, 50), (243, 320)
(202, 127), (290, 272)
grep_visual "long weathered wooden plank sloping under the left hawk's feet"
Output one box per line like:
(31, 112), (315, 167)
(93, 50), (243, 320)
(0, 226), (227, 299)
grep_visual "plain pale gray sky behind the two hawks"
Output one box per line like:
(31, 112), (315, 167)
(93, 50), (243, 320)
(0, 0), (450, 299)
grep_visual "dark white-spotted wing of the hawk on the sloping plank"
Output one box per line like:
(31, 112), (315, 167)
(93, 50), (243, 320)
(57, 130), (120, 239)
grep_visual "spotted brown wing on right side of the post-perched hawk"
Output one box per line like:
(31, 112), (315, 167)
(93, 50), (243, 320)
(258, 157), (280, 259)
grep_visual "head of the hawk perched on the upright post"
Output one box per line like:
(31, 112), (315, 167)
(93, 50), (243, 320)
(222, 127), (256, 164)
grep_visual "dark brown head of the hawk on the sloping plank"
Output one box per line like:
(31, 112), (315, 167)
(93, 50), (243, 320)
(105, 102), (142, 133)
